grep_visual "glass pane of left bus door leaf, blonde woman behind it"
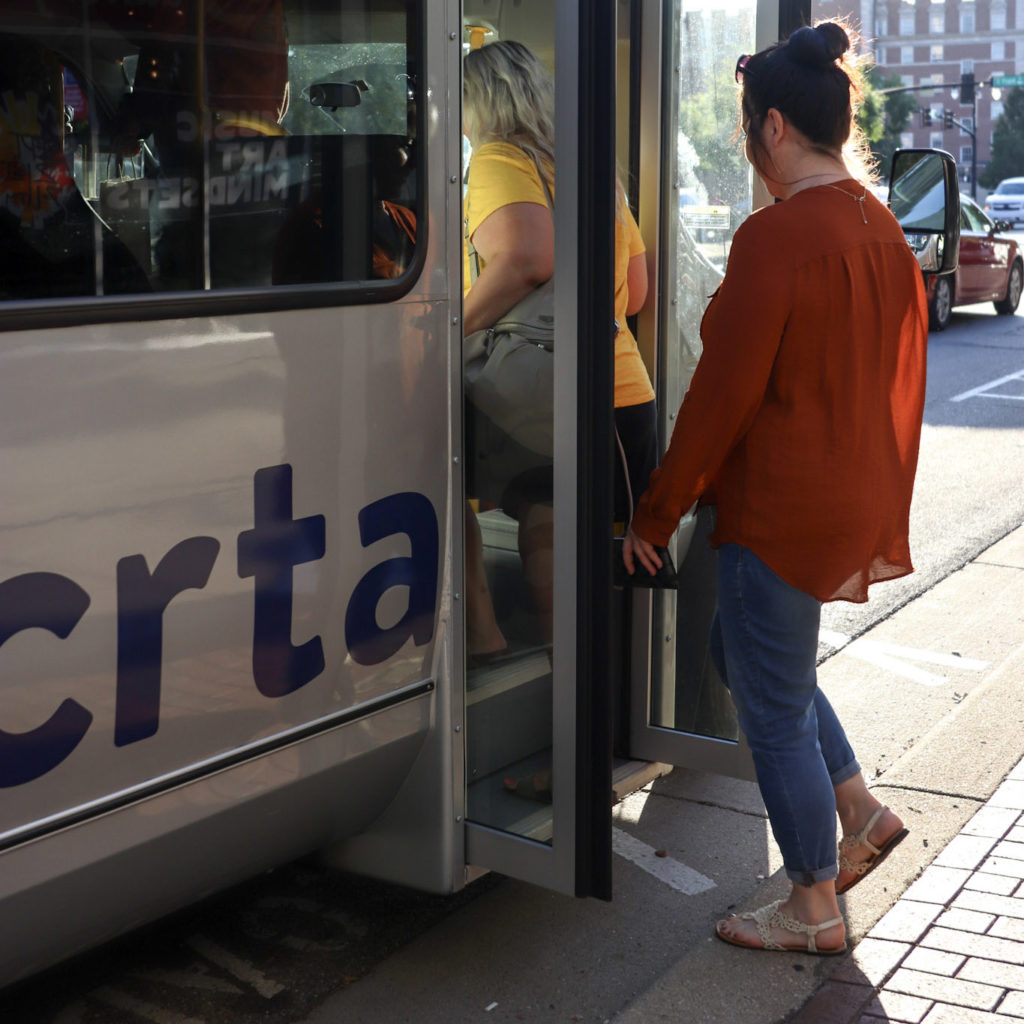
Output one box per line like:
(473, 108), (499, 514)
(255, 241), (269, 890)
(463, 2), (555, 843)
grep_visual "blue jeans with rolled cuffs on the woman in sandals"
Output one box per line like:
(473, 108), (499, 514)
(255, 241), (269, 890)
(711, 544), (860, 886)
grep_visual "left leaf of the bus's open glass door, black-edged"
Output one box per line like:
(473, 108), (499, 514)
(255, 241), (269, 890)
(462, 0), (614, 896)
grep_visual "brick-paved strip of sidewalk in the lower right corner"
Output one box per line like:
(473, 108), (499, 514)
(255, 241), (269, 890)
(788, 761), (1024, 1024)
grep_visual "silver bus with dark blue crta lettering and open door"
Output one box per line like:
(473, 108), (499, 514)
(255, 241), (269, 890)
(0, 0), (954, 984)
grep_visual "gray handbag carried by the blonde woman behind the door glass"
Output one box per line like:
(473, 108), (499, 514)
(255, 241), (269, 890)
(463, 150), (555, 459)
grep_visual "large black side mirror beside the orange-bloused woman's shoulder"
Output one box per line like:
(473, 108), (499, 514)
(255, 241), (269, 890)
(889, 150), (959, 273)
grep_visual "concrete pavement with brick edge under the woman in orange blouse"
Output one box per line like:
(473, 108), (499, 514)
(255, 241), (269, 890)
(306, 527), (1024, 1024)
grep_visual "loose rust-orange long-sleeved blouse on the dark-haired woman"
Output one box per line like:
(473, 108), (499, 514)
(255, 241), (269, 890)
(632, 180), (928, 601)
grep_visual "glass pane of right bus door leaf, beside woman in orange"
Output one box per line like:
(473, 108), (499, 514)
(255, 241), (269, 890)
(649, 0), (756, 739)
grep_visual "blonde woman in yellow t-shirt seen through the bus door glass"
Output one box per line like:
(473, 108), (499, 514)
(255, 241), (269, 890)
(463, 41), (555, 664)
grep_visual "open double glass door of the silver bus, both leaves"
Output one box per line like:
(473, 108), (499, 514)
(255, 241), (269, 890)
(455, 0), (798, 895)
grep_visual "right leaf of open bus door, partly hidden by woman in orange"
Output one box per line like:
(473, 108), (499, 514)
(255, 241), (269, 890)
(630, 0), (779, 778)
